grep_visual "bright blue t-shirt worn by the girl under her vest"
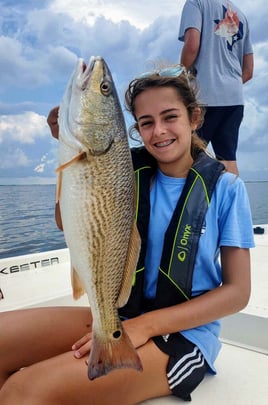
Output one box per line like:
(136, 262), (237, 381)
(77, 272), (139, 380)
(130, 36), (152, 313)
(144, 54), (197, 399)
(145, 170), (254, 373)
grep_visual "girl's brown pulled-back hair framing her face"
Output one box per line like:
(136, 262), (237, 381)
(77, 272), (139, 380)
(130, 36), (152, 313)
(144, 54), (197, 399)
(125, 67), (206, 159)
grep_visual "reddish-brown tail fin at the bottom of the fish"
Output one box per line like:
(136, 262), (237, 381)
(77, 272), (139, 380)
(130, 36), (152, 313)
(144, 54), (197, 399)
(88, 322), (143, 380)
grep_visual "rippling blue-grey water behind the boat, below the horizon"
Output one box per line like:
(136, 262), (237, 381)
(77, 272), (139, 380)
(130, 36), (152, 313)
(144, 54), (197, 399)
(0, 182), (268, 259)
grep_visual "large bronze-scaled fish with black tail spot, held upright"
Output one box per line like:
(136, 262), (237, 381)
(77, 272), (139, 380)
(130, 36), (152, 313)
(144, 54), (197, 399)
(54, 57), (142, 379)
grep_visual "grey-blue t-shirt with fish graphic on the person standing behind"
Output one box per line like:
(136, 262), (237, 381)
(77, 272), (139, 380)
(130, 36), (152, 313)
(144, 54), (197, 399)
(179, 0), (253, 106)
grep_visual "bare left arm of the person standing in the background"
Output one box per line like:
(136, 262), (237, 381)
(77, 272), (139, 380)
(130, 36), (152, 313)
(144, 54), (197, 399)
(180, 28), (200, 69)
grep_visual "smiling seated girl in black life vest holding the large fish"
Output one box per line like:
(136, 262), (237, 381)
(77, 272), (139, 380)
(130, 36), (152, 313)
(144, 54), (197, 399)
(0, 66), (254, 405)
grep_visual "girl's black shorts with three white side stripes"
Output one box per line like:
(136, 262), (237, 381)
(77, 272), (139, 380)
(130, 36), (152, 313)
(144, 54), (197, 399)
(153, 333), (208, 401)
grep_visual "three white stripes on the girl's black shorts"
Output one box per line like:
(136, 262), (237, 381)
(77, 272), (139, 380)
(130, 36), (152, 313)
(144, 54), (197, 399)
(167, 346), (205, 390)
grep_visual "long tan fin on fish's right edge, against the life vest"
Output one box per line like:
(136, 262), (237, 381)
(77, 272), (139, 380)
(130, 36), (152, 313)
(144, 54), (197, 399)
(115, 222), (141, 308)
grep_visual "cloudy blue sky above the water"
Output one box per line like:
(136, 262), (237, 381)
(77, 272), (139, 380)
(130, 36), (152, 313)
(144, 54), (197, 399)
(0, 0), (268, 185)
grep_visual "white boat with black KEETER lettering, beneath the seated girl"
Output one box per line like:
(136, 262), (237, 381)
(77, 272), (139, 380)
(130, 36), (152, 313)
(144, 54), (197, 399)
(0, 224), (268, 405)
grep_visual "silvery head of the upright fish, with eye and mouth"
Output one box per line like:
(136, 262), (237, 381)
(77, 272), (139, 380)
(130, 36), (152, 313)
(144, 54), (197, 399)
(59, 57), (127, 155)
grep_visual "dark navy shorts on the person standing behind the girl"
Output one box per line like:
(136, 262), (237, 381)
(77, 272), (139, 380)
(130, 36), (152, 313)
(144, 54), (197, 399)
(197, 105), (244, 160)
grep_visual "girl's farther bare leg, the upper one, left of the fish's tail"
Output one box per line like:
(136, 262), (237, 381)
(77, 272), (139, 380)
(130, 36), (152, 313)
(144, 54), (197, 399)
(0, 307), (92, 388)
